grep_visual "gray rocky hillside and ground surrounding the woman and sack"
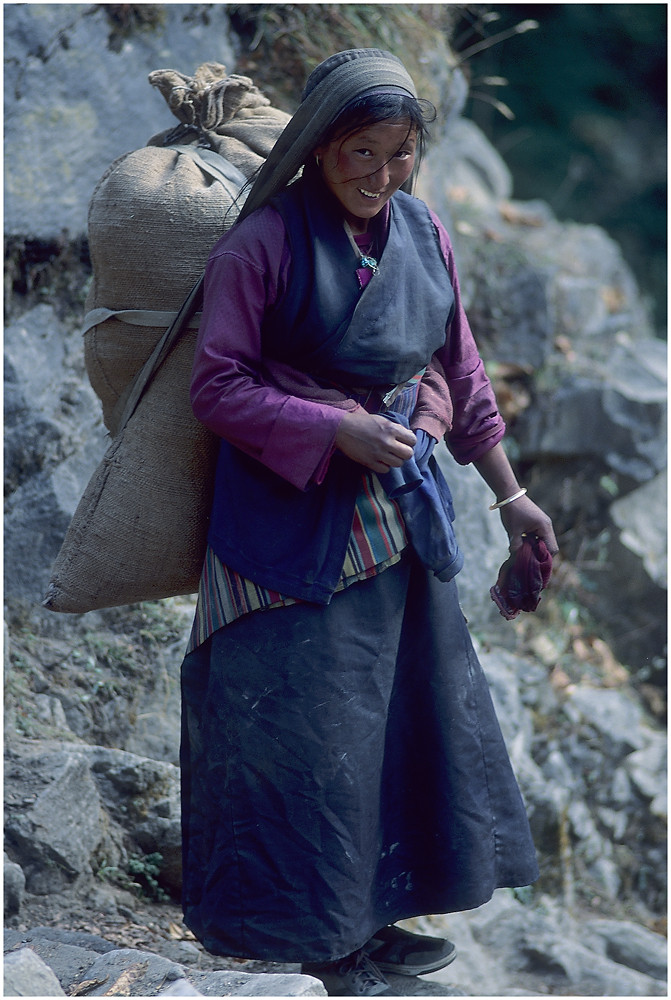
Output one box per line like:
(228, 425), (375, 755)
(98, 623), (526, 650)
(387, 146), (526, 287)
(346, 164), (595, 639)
(5, 4), (666, 996)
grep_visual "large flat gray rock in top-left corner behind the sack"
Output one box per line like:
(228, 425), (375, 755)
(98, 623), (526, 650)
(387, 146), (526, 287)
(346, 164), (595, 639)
(4, 4), (234, 238)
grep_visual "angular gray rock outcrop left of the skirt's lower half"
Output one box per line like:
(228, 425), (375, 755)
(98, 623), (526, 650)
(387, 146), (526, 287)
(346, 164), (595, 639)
(5, 743), (181, 894)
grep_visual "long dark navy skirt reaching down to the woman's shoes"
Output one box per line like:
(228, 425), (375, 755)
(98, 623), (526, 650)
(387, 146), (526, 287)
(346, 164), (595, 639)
(182, 552), (538, 962)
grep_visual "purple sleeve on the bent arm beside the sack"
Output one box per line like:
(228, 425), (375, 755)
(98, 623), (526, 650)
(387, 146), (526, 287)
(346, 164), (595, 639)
(191, 208), (344, 489)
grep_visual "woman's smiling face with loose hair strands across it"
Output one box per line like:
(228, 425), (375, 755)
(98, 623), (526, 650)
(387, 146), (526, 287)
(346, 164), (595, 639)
(315, 121), (417, 233)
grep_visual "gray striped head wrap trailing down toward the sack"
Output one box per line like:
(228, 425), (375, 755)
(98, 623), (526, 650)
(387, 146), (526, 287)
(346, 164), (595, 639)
(238, 49), (417, 220)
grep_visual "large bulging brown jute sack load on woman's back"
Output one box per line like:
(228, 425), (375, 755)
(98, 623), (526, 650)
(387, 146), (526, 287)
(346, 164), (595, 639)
(43, 63), (289, 613)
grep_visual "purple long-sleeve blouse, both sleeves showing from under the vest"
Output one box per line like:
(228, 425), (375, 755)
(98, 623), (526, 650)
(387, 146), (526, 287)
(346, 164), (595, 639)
(191, 206), (505, 489)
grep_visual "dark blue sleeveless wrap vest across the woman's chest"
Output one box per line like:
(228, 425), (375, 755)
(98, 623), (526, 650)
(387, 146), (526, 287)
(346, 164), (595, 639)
(263, 177), (454, 385)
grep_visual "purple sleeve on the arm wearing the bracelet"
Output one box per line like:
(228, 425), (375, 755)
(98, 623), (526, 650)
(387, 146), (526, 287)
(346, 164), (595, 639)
(431, 212), (505, 465)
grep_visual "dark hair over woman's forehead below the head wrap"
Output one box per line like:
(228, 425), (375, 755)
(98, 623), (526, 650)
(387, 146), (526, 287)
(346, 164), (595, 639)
(319, 91), (436, 166)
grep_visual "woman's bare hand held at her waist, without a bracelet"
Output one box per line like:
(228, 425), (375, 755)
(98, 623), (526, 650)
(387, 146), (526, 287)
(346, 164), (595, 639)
(335, 407), (417, 473)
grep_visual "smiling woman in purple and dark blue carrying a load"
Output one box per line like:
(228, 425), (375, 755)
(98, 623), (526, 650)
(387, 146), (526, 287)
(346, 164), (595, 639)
(182, 49), (557, 996)
